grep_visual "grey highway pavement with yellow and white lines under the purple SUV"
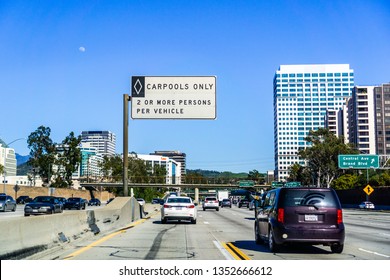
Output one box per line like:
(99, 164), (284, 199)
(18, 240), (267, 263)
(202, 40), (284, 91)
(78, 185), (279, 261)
(30, 203), (390, 260)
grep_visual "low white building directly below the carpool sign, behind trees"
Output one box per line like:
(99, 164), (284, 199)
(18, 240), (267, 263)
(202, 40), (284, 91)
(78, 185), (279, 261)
(129, 153), (181, 185)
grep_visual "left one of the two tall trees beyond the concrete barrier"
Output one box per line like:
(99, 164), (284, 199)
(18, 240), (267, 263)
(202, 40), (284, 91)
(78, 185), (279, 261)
(27, 126), (55, 184)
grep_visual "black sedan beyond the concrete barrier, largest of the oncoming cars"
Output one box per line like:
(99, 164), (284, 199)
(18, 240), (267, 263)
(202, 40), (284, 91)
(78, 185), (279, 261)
(24, 196), (62, 216)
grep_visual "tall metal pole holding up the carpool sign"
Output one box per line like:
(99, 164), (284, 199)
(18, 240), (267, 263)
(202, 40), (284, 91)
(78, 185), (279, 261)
(123, 94), (130, 196)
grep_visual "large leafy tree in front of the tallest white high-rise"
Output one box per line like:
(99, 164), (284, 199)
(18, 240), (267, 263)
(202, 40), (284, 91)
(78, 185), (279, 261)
(298, 128), (357, 188)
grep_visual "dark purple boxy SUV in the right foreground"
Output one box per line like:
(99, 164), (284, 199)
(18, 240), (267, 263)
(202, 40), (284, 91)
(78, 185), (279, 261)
(255, 187), (345, 253)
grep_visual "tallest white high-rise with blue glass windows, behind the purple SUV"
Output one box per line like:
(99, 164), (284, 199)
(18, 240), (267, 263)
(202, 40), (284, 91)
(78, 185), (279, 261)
(273, 64), (354, 181)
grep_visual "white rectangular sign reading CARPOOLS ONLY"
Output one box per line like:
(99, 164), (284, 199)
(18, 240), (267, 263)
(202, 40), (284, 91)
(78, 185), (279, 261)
(131, 76), (216, 119)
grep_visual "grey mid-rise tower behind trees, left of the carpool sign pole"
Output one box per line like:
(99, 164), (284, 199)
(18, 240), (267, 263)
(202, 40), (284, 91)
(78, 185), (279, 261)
(81, 131), (116, 155)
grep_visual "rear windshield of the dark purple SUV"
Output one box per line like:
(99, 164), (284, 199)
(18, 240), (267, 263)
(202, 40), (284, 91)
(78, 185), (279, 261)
(281, 189), (338, 207)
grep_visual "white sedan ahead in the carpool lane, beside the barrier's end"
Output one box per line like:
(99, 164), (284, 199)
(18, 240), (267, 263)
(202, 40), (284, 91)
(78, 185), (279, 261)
(161, 196), (197, 224)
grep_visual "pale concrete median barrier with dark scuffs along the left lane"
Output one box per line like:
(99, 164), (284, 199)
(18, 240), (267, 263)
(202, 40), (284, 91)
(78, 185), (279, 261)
(0, 197), (141, 259)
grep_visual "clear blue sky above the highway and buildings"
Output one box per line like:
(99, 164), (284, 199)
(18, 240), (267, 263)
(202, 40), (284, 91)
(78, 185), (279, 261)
(0, 0), (390, 172)
